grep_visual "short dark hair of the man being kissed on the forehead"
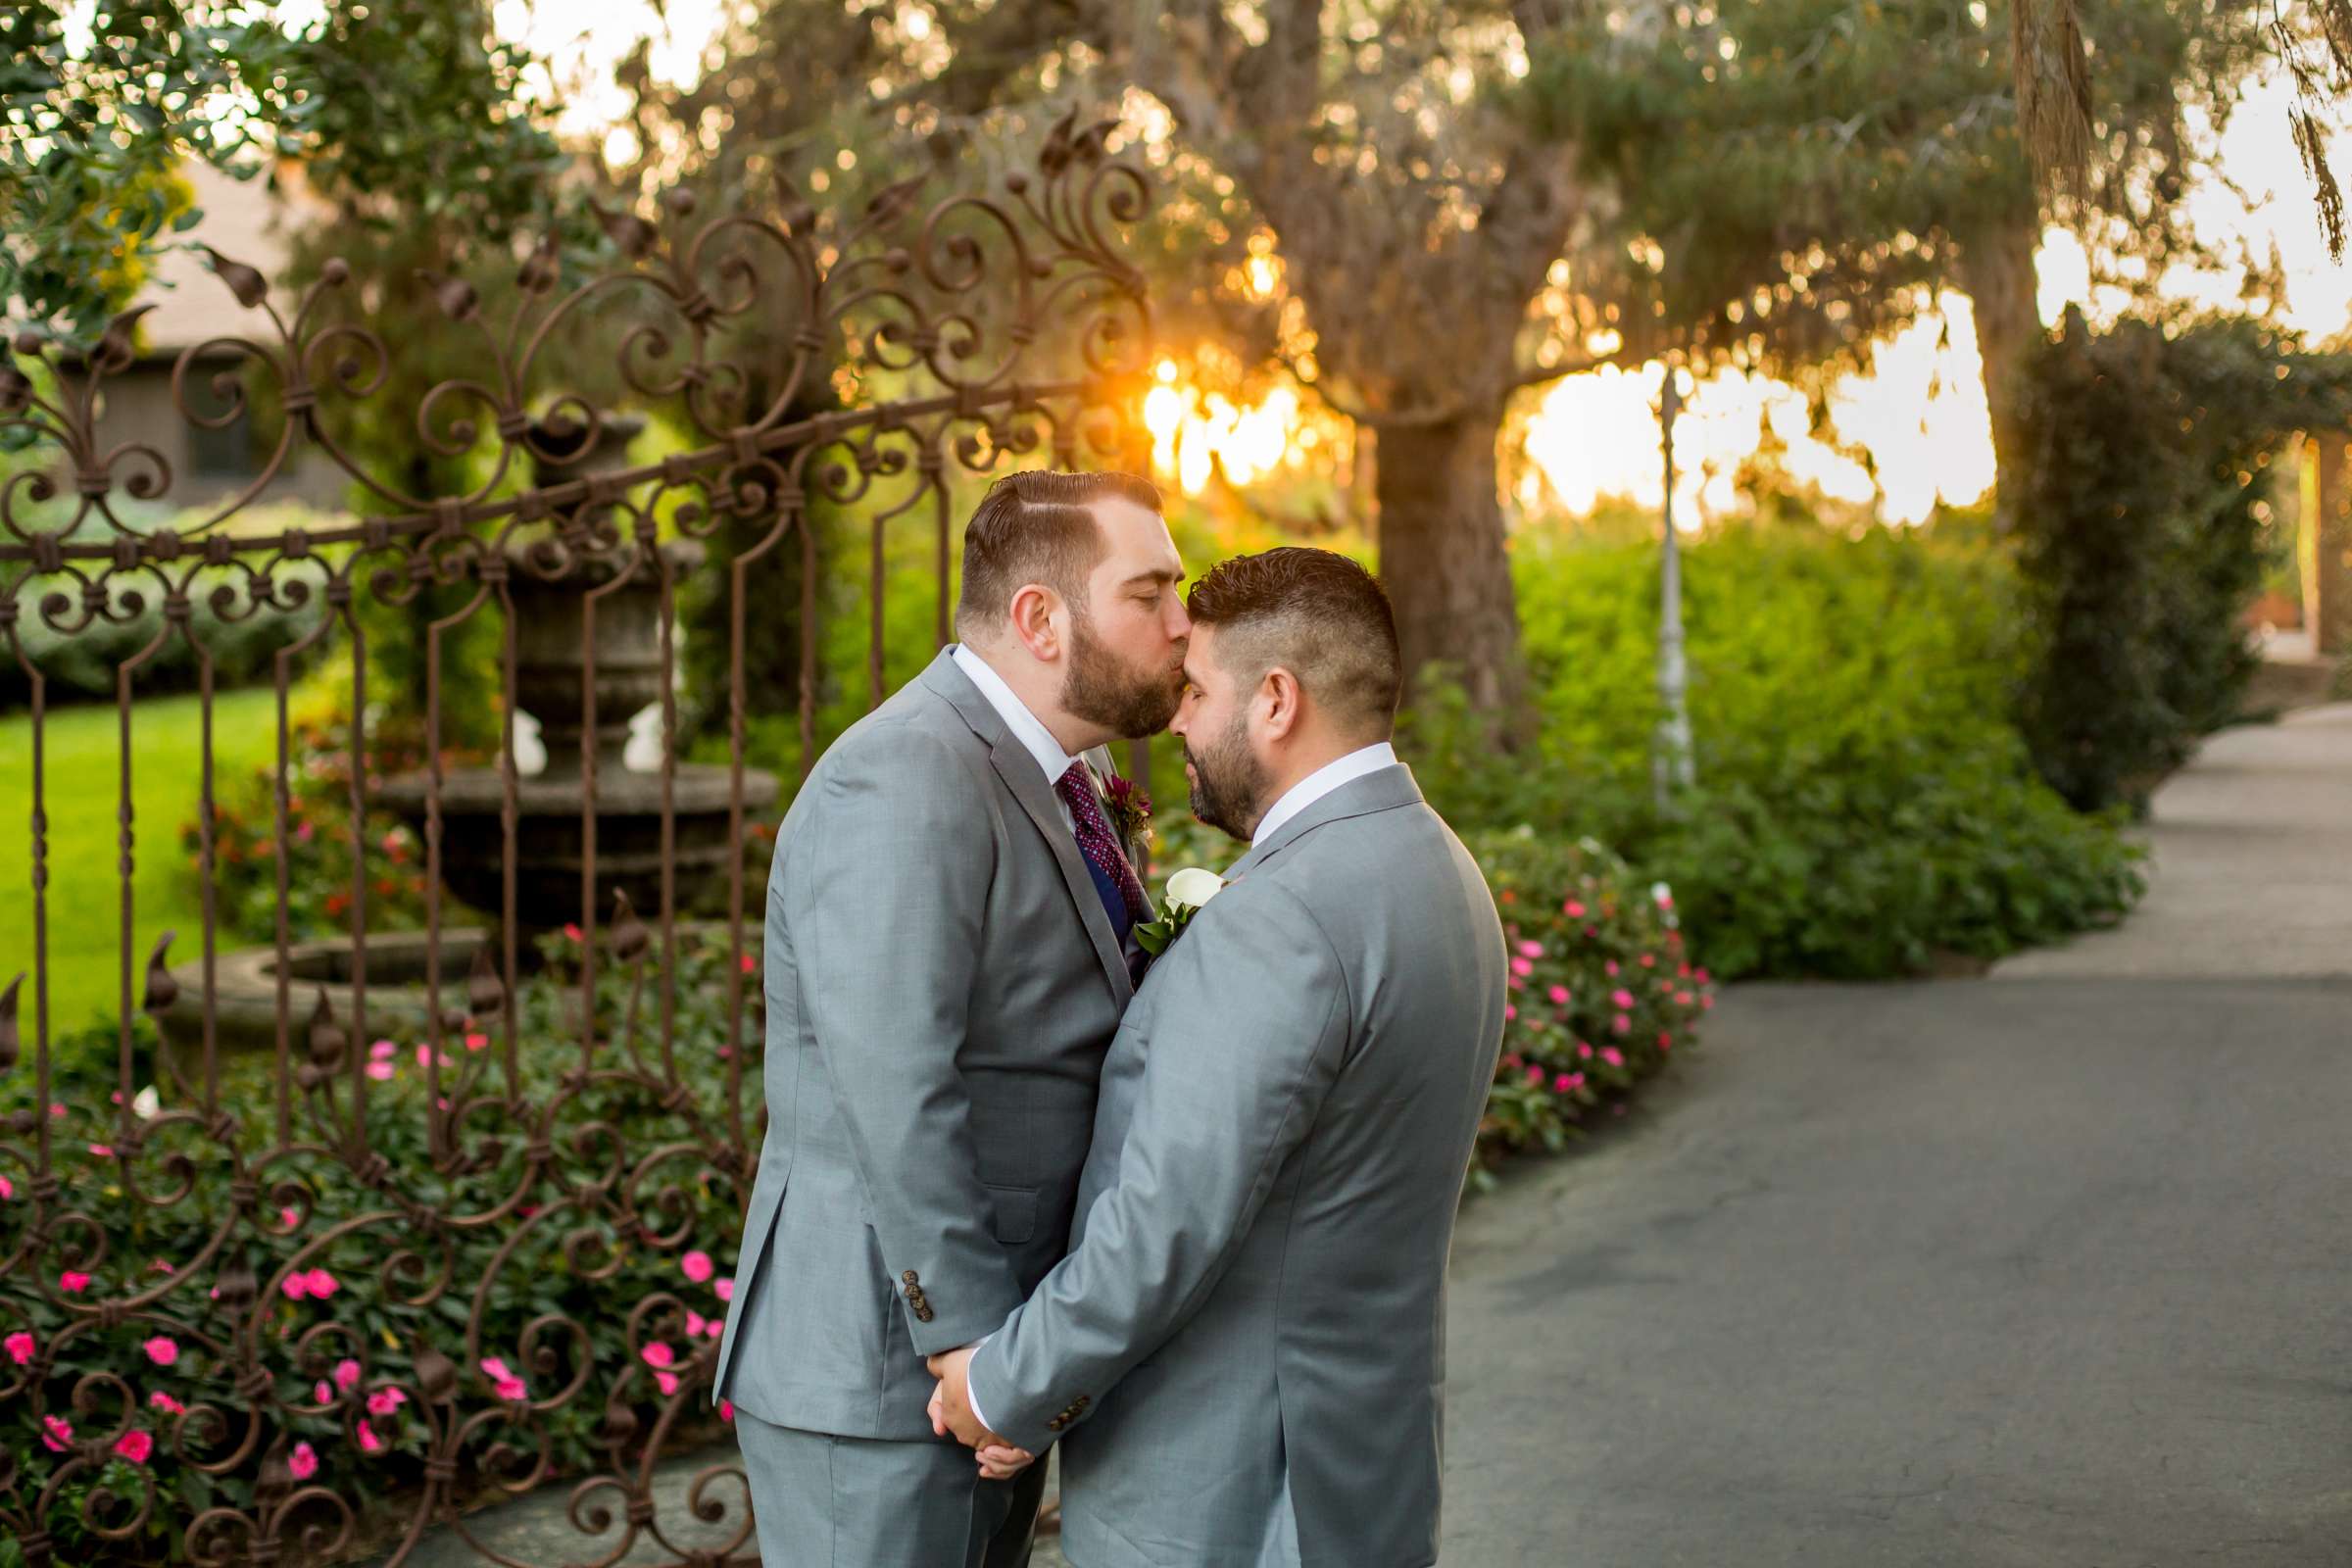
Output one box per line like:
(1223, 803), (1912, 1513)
(1186, 546), (1404, 741)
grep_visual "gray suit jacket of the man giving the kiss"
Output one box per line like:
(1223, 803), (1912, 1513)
(712, 654), (1131, 1441)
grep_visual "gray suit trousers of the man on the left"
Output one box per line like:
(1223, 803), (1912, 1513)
(734, 1408), (1045, 1568)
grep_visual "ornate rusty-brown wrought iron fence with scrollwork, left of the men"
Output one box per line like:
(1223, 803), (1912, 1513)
(0, 120), (1151, 1568)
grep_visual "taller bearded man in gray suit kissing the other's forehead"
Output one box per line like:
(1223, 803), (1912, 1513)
(712, 472), (1190, 1568)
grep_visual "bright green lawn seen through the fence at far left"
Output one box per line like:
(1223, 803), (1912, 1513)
(0, 689), (277, 1034)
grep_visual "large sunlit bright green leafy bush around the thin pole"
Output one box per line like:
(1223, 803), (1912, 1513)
(1404, 524), (2140, 978)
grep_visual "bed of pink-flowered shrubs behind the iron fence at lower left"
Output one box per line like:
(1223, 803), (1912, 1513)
(0, 926), (760, 1568)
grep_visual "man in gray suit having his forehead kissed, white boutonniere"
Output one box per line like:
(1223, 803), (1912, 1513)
(931, 550), (1505, 1568)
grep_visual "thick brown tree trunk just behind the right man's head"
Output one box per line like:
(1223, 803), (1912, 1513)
(1374, 405), (1524, 731)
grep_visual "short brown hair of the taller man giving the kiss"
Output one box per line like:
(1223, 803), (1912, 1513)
(955, 470), (1159, 637)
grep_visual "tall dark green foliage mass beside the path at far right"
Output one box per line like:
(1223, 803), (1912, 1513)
(2016, 311), (2352, 811)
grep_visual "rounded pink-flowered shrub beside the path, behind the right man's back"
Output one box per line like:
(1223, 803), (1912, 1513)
(1472, 832), (1715, 1185)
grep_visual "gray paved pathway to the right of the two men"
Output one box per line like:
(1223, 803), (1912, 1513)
(1445, 706), (2352, 1568)
